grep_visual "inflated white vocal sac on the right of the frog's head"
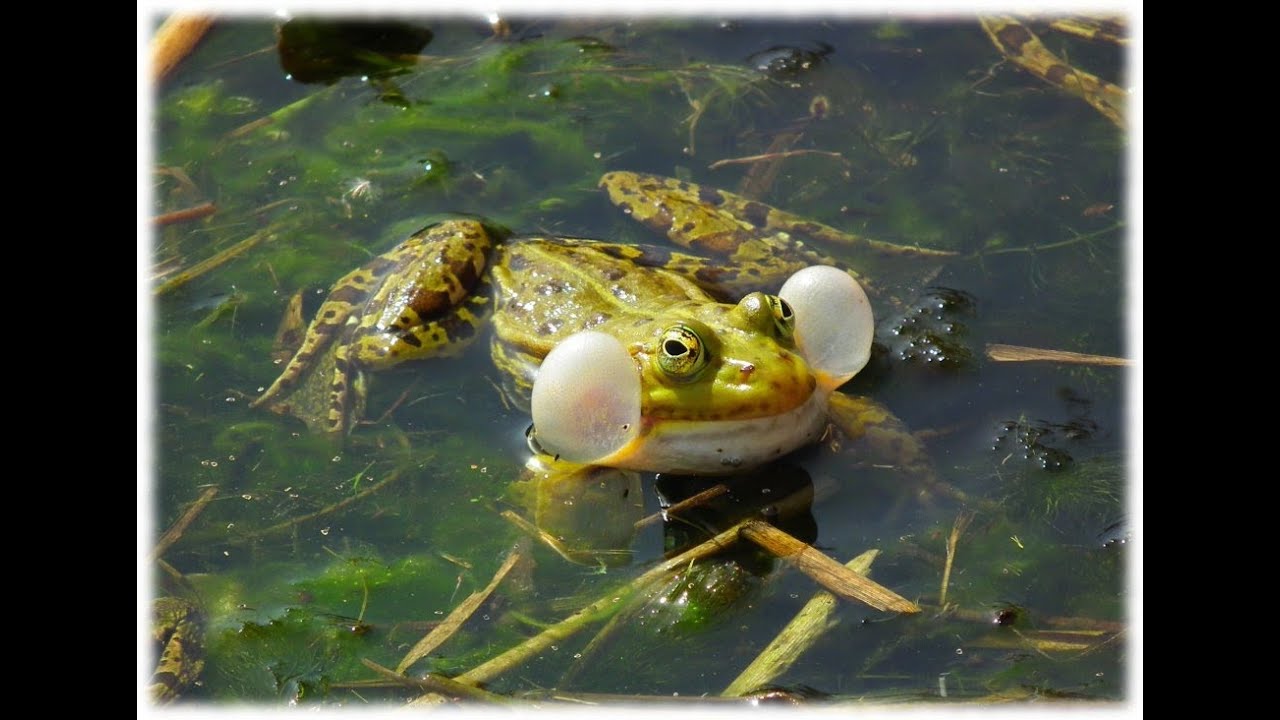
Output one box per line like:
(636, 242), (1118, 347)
(778, 265), (876, 389)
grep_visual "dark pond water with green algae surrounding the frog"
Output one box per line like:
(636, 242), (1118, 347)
(140, 17), (1137, 707)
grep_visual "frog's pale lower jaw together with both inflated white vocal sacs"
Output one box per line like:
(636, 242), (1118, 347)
(531, 266), (874, 473)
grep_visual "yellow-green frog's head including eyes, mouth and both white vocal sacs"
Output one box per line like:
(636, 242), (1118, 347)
(531, 266), (874, 473)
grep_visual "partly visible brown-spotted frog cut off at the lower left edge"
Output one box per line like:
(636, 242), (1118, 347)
(148, 596), (205, 705)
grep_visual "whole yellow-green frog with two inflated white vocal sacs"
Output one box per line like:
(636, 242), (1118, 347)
(253, 172), (950, 474)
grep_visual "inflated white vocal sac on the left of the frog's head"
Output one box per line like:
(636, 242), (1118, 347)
(530, 331), (640, 464)
